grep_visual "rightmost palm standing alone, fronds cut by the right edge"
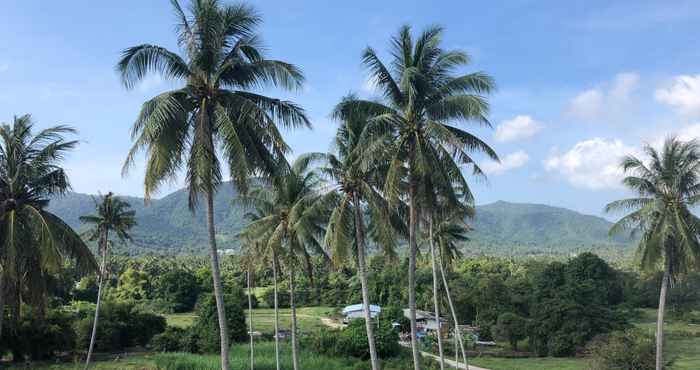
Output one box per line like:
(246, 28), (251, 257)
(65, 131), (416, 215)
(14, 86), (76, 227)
(606, 137), (700, 370)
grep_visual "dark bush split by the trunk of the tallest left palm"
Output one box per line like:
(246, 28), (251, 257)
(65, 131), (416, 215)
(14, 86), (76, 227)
(190, 294), (248, 353)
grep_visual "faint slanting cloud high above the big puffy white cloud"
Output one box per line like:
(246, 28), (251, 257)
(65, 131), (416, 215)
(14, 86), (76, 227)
(566, 72), (639, 120)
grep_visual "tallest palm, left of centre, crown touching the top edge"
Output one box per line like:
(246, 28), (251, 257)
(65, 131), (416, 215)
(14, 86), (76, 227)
(117, 0), (310, 369)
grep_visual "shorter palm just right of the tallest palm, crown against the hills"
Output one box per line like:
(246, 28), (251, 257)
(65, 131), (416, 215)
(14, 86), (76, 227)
(242, 157), (328, 370)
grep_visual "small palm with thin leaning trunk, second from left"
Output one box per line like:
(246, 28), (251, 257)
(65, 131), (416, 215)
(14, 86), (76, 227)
(80, 192), (136, 370)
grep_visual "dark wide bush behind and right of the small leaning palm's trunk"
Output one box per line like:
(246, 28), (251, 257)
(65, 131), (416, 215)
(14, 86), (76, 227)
(77, 301), (166, 351)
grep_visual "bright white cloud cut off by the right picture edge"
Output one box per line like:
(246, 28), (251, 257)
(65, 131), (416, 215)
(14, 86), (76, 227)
(654, 74), (700, 115)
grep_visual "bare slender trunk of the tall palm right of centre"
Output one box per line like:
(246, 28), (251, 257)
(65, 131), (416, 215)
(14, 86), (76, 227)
(408, 176), (420, 370)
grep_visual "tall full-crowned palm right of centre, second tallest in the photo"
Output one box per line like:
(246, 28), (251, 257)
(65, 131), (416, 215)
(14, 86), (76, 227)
(338, 26), (498, 370)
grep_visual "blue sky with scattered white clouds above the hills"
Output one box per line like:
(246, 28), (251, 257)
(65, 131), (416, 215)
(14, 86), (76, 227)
(0, 0), (700, 217)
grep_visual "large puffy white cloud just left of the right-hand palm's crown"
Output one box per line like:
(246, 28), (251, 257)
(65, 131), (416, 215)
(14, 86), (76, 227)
(544, 138), (639, 190)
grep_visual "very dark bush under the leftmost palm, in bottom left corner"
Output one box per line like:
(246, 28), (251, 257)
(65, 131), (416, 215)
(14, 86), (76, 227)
(0, 306), (75, 360)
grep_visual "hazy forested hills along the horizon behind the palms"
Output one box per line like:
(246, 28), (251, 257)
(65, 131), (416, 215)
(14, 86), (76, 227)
(49, 184), (629, 255)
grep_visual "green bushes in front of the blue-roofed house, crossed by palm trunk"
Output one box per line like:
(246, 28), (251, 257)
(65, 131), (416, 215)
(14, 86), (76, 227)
(303, 319), (401, 359)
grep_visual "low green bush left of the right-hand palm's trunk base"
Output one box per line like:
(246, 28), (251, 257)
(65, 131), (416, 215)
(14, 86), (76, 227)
(588, 330), (656, 370)
